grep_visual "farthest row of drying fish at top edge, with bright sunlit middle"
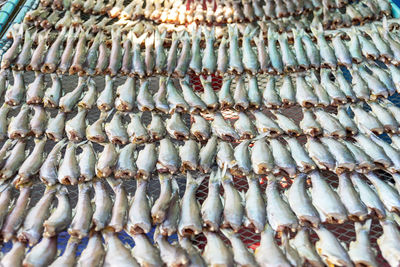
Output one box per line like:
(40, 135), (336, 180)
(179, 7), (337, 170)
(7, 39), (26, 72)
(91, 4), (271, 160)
(40, 0), (352, 24)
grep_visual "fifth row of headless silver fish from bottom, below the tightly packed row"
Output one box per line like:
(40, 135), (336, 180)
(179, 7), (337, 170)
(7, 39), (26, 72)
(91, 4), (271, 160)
(0, 63), (400, 111)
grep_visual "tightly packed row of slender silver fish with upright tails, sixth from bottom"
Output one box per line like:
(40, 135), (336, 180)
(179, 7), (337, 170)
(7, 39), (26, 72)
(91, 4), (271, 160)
(1, 19), (400, 77)
